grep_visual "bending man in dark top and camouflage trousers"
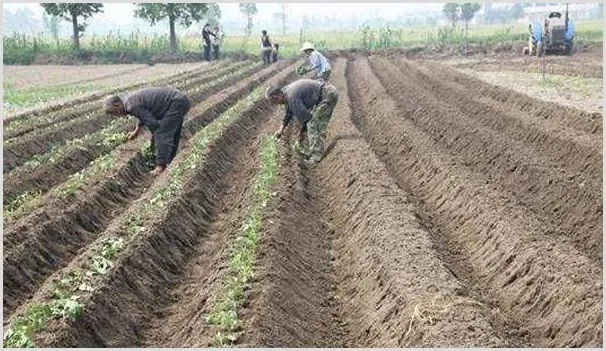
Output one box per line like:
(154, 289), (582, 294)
(265, 79), (339, 166)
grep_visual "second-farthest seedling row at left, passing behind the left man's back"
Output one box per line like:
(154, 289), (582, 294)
(5, 62), (252, 140)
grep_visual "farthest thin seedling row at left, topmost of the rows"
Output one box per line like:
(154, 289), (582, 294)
(4, 59), (224, 126)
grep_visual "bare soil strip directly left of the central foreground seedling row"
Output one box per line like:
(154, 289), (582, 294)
(135, 110), (279, 348)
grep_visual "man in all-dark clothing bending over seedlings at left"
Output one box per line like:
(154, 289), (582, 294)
(106, 87), (191, 174)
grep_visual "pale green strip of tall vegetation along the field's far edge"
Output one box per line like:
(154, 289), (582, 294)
(3, 19), (603, 64)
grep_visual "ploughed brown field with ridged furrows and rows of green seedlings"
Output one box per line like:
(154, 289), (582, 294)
(3, 48), (603, 347)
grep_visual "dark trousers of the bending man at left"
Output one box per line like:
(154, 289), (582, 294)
(153, 96), (191, 165)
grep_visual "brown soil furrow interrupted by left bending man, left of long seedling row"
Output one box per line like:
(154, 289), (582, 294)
(3, 62), (294, 318)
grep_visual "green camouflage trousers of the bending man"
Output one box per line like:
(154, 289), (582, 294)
(307, 83), (339, 162)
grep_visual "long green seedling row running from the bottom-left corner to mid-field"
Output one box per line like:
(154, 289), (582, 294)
(4, 88), (263, 347)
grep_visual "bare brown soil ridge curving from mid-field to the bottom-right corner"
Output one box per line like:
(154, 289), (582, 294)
(348, 59), (602, 347)
